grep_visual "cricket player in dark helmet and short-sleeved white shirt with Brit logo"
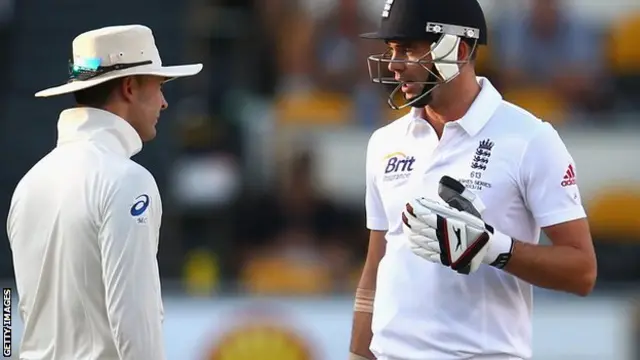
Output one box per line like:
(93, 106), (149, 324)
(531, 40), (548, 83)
(350, 0), (597, 360)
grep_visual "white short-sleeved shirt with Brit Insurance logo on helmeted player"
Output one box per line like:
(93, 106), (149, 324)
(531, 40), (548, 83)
(366, 78), (585, 360)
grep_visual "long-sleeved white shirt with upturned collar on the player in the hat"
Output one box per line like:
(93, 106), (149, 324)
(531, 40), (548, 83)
(7, 108), (165, 360)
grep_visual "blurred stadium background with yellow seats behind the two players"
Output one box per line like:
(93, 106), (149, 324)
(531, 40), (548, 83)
(0, 0), (640, 360)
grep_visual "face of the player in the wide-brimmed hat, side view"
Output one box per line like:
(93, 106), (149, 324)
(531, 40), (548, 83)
(129, 76), (168, 141)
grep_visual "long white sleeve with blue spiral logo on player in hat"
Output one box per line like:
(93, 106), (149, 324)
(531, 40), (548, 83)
(99, 169), (165, 360)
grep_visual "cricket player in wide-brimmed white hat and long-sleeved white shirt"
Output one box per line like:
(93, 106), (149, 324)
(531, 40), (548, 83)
(7, 25), (202, 360)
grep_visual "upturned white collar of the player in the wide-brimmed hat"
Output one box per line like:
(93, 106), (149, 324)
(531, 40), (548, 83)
(58, 107), (142, 157)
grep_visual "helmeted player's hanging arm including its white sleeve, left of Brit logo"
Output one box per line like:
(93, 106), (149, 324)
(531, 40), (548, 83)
(350, 133), (389, 360)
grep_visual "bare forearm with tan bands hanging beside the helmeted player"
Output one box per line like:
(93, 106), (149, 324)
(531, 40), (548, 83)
(350, 230), (386, 359)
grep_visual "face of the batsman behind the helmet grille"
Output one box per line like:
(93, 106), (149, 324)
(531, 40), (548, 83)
(387, 41), (433, 99)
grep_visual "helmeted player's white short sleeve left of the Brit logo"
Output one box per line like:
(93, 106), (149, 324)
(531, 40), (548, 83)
(365, 133), (389, 231)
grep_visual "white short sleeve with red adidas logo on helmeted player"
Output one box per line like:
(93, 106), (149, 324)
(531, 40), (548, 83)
(520, 123), (586, 227)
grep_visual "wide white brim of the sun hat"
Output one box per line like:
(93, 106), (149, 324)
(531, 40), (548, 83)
(35, 64), (202, 97)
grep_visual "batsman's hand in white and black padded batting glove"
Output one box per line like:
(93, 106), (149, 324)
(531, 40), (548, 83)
(402, 198), (513, 274)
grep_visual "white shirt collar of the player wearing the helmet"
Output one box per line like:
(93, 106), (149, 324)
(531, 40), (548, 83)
(409, 77), (502, 136)
